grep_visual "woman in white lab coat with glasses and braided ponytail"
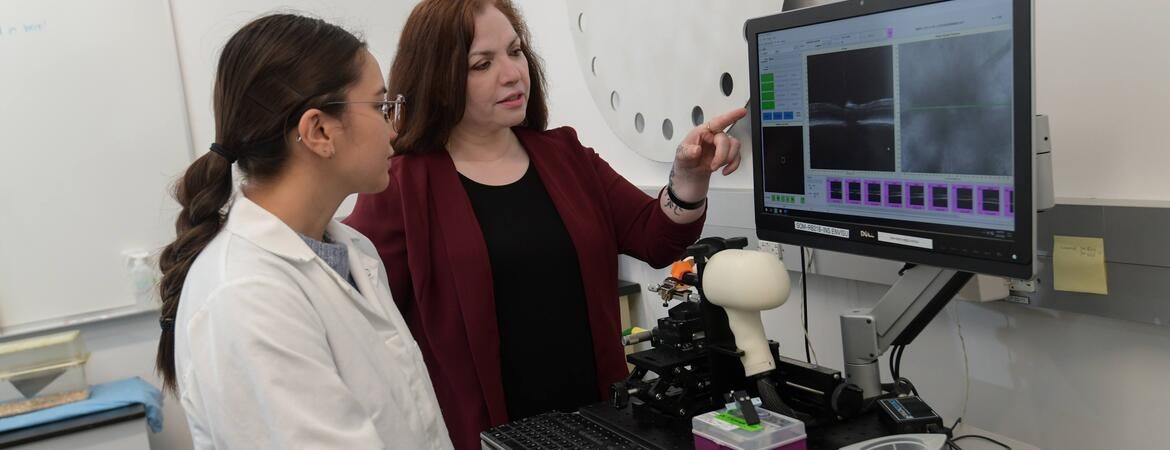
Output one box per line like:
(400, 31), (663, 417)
(157, 15), (450, 449)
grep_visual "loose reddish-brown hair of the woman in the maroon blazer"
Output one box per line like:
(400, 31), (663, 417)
(390, 0), (549, 154)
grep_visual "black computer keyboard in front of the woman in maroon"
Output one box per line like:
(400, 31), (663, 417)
(480, 411), (646, 450)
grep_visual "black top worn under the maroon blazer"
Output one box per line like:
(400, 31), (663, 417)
(460, 164), (600, 421)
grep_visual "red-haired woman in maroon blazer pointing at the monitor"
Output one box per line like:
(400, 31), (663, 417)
(346, 0), (746, 449)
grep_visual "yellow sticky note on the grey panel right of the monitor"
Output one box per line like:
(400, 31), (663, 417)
(1052, 236), (1109, 296)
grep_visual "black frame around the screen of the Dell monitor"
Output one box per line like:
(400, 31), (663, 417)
(744, 0), (1035, 278)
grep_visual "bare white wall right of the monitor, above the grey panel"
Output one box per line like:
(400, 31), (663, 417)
(1035, 0), (1170, 202)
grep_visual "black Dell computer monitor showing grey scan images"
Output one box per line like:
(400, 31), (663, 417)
(744, 0), (1035, 278)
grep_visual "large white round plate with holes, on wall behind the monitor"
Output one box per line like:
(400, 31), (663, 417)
(566, 0), (782, 162)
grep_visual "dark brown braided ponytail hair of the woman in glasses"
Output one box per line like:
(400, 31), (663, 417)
(154, 14), (365, 393)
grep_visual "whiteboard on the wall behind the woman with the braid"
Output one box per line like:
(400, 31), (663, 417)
(0, 0), (191, 328)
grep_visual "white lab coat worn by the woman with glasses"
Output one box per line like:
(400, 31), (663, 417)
(176, 195), (452, 450)
